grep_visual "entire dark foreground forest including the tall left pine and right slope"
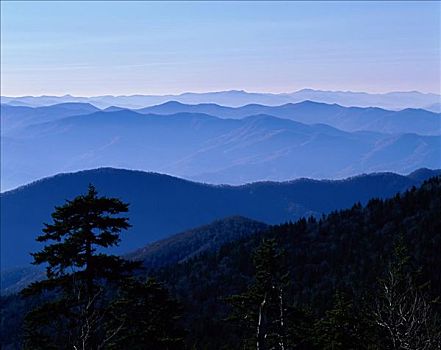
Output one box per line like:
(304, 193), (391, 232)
(1, 176), (441, 350)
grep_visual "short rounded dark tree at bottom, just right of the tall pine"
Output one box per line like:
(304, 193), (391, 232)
(107, 278), (184, 350)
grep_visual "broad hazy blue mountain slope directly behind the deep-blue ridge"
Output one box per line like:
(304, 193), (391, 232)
(1, 110), (441, 190)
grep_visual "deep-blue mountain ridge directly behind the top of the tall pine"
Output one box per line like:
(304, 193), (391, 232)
(0, 168), (439, 268)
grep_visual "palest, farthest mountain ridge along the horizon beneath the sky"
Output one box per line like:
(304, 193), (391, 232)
(1, 89), (440, 109)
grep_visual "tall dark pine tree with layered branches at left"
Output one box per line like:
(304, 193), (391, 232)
(22, 185), (138, 349)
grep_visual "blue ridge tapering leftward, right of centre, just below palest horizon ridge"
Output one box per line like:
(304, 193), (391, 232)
(136, 101), (441, 135)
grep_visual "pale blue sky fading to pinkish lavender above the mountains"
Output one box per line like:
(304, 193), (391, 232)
(1, 1), (441, 96)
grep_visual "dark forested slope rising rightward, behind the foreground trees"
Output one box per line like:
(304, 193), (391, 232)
(151, 177), (441, 349)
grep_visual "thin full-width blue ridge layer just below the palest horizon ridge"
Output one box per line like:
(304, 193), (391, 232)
(1, 100), (441, 135)
